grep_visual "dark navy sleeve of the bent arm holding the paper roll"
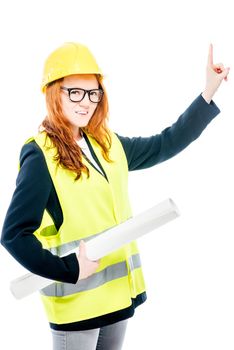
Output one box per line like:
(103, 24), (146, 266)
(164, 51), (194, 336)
(1, 144), (79, 283)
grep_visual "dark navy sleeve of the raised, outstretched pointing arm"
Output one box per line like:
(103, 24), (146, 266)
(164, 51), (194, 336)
(118, 95), (220, 171)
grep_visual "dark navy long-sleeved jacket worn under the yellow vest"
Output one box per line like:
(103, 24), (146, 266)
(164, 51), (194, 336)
(1, 95), (220, 329)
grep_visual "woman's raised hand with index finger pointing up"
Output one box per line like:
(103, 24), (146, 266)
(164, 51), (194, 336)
(202, 44), (230, 103)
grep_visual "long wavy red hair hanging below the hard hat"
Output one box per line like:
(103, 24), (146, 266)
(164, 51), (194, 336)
(39, 75), (112, 180)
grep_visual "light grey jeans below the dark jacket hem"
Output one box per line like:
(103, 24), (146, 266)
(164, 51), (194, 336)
(51, 320), (127, 350)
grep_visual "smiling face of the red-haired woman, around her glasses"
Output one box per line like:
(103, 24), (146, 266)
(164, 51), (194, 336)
(61, 74), (99, 139)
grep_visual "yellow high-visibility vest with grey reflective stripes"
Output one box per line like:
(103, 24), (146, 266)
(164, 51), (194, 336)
(27, 132), (145, 324)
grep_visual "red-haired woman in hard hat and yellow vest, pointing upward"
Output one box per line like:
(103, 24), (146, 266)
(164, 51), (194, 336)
(1, 43), (229, 350)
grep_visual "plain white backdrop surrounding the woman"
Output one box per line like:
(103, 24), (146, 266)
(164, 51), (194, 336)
(0, 0), (234, 350)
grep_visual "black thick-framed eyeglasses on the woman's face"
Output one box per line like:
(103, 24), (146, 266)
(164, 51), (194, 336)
(61, 86), (104, 103)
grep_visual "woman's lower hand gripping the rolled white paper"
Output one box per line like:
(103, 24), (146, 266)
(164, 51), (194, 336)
(76, 241), (99, 280)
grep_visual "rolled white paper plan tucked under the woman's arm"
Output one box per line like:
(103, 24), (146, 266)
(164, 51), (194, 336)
(10, 199), (179, 299)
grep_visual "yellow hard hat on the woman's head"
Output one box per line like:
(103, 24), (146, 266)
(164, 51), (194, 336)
(41, 42), (102, 92)
